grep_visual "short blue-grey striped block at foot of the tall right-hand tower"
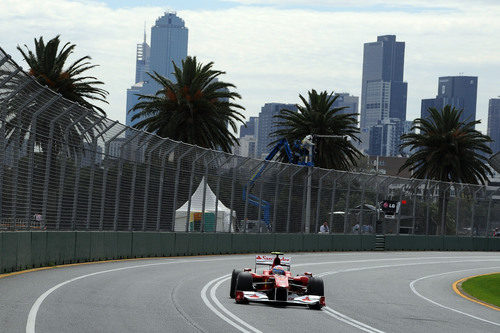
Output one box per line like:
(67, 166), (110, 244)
(367, 118), (412, 156)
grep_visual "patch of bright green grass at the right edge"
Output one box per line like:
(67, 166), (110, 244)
(462, 273), (500, 307)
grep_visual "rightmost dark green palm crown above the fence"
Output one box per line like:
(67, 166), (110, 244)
(400, 105), (492, 184)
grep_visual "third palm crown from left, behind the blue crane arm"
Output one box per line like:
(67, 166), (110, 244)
(271, 89), (361, 170)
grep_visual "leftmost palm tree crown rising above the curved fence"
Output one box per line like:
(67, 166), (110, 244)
(17, 35), (108, 114)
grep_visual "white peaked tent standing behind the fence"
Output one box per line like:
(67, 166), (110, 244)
(174, 177), (236, 232)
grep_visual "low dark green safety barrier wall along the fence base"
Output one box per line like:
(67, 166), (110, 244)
(0, 231), (500, 273)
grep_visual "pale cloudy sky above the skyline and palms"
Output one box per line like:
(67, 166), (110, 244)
(0, 0), (500, 132)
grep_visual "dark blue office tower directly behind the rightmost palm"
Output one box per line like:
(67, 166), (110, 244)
(420, 76), (477, 121)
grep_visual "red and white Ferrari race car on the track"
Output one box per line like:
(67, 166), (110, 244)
(229, 252), (325, 310)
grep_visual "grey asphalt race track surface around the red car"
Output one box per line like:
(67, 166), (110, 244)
(0, 252), (500, 333)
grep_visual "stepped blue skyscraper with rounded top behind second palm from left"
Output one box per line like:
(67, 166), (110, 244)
(127, 12), (188, 126)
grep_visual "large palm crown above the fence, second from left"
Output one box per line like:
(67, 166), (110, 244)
(129, 57), (245, 152)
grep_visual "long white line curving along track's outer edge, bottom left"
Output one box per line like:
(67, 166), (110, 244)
(26, 259), (235, 333)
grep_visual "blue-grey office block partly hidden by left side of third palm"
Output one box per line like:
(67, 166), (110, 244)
(256, 103), (297, 158)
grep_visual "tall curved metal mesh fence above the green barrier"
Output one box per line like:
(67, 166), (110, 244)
(0, 49), (500, 236)
